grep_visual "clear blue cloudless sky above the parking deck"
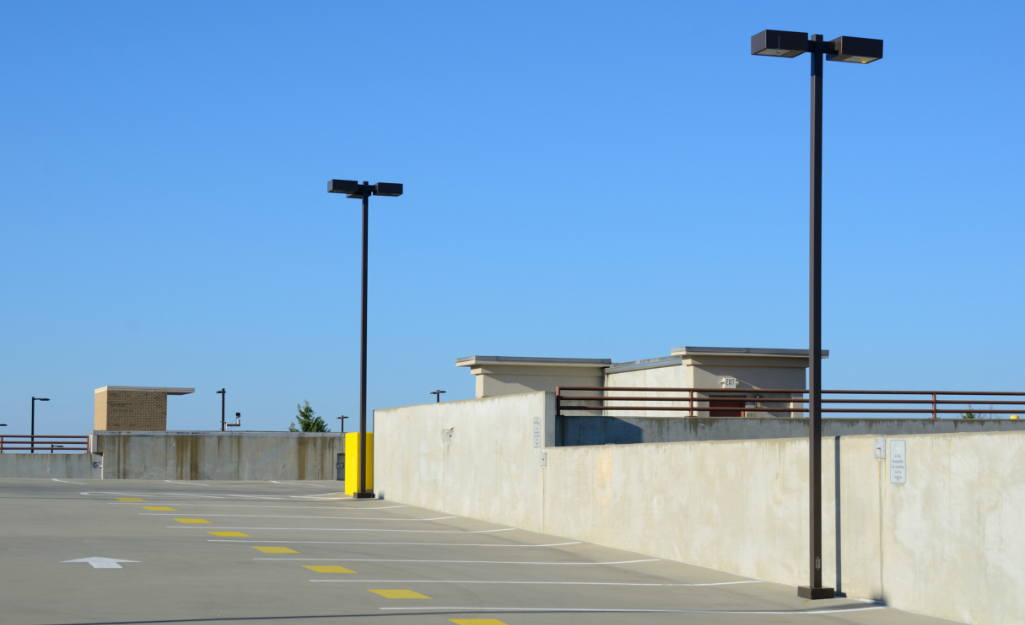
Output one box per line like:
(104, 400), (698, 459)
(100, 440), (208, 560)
(0, 1), (1025, 434)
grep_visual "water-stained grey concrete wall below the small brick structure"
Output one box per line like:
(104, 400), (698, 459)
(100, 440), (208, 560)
(92, 431), (344, 480)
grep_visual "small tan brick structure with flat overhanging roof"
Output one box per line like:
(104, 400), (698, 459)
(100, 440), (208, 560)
(92, 386), (196, 431)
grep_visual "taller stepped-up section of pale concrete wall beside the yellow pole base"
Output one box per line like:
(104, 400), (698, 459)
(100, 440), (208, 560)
(374, 392), (555, 530)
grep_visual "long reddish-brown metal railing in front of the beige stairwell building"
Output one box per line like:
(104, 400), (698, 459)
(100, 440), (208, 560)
(556, 386), (1025, 419)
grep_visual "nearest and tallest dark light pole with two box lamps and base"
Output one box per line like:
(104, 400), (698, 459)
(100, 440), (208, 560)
(751, 31), (883, 599)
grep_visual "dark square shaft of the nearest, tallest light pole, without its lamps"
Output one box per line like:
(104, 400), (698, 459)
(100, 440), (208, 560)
(808, 35), (825, 589)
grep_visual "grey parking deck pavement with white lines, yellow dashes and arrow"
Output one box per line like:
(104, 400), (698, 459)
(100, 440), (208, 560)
(0, 480), (947, 625)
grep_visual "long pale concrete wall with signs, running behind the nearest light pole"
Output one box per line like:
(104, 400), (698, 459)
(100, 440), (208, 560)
(375, 393), (1025, 625)
